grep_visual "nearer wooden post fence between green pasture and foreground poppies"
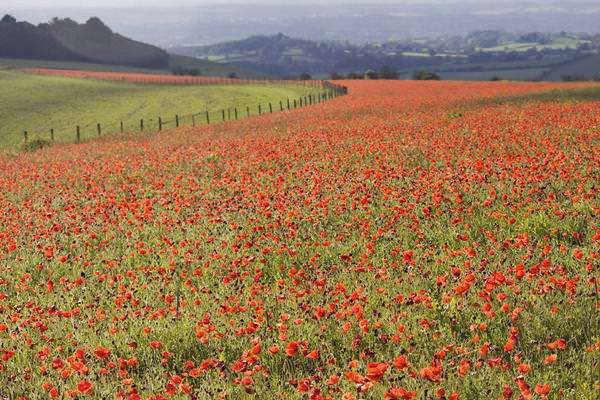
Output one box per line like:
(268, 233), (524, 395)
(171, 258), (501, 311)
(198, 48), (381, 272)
(23, 81), (348, 145)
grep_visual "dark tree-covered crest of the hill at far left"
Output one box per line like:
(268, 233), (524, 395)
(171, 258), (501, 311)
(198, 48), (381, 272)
(0, 16), (169, 68)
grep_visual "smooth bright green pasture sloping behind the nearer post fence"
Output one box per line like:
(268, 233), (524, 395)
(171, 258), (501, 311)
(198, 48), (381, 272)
(0, 70), (316, 147)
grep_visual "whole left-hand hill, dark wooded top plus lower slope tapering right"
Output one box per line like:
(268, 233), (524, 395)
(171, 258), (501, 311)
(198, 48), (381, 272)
(0, 15), (265, 78)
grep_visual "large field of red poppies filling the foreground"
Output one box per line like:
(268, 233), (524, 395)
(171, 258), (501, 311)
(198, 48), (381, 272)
(0, 81), (600, 400)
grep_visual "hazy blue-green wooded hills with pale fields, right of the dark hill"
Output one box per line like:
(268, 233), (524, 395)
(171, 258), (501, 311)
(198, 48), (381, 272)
(175, 30), (600, 80)
